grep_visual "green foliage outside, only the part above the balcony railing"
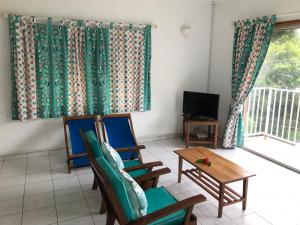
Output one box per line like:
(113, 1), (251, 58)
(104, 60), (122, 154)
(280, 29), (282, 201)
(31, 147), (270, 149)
(256, 29), (300, 89)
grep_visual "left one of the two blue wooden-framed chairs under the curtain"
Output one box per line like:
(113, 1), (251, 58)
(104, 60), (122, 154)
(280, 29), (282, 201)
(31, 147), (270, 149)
(63, 115), (101, 173)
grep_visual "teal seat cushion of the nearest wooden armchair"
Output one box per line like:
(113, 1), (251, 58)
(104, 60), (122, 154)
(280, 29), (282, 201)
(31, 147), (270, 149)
(145, 187), (185, 225)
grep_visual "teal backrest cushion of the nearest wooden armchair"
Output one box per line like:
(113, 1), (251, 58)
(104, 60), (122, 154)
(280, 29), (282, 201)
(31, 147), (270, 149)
(96, 157), (137, 220)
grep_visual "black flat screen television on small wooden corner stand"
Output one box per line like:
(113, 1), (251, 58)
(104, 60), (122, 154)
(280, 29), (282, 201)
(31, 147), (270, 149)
(182, 91), (220, 119)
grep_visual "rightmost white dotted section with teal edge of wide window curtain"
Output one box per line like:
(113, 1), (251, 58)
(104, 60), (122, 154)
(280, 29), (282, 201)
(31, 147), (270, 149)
(109, 25), (151, 113)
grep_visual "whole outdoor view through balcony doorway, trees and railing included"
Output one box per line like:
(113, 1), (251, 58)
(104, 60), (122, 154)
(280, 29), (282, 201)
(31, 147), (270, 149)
(244, 28), (300, 171)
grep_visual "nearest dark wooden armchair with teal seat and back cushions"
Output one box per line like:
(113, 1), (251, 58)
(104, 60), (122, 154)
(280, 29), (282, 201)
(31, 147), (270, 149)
(81, 132), (206, 225)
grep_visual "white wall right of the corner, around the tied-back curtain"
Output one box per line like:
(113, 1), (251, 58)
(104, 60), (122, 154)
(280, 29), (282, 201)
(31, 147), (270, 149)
(209, 0), (300, 136)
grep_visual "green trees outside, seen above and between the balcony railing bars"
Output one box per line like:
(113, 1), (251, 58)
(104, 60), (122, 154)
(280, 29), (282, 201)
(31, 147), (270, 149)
(247, 28), (300, 142)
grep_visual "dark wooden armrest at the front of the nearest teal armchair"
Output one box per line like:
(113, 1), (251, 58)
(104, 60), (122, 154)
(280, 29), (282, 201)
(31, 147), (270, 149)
(128, 195), (206, 225)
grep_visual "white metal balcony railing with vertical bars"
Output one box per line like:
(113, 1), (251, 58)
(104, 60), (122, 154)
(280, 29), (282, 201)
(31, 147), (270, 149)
(244, 87), (300, 144)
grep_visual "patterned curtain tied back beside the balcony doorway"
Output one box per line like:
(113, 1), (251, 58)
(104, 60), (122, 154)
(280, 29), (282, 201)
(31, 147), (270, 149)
(223, 15), (276, 148)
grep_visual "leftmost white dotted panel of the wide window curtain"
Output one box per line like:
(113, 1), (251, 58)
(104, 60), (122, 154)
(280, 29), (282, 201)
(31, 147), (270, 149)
(9, 17), (38, 120)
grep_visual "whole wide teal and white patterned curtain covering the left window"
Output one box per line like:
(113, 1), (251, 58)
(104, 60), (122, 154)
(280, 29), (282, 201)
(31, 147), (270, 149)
(9, 15), (151, 121)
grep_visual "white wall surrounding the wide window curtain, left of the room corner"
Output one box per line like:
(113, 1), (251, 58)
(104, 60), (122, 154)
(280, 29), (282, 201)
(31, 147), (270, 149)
(0, 0), (211, 155)
